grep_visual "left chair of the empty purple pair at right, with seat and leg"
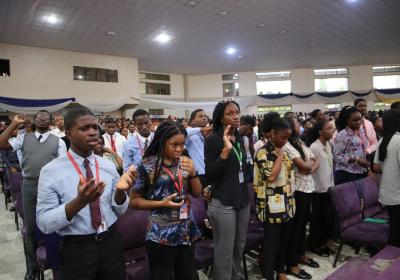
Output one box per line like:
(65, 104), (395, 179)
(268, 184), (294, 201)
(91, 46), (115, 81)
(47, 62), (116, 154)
(329, 182), (389, 267)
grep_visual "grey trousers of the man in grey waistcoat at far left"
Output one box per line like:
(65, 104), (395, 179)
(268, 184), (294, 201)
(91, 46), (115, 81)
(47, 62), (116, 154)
(22, 179), (38, 271)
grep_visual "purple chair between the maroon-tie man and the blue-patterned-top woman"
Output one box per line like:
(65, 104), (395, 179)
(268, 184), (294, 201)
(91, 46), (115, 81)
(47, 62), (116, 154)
(116, 209), (150, 280)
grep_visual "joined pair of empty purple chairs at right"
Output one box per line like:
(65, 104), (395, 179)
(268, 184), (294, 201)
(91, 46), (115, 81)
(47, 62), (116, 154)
(329, 176), (389, 267)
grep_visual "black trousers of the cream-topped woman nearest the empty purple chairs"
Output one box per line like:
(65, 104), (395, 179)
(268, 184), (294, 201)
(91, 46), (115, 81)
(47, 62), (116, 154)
(308, 192), (335, 249)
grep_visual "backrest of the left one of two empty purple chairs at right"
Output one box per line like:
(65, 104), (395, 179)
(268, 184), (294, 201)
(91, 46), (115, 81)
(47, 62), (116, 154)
(329, 182), (362, 230)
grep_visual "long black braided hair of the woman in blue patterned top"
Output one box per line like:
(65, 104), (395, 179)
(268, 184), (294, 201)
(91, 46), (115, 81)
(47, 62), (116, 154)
(143, 120), (187, 189)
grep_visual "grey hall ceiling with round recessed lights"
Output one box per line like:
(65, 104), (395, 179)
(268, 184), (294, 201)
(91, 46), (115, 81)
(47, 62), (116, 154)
(0, 0), (400, 74)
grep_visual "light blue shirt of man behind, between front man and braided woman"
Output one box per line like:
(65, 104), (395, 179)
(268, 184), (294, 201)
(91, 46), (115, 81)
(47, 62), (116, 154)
(122, 132), (154, 172)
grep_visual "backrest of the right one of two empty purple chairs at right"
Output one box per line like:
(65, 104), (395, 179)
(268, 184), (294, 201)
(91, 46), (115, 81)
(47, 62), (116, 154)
(354, 176), (383, 217)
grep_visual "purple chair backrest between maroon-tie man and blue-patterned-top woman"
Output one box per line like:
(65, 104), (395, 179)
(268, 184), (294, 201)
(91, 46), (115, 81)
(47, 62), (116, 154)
(116, 208), (150, 250)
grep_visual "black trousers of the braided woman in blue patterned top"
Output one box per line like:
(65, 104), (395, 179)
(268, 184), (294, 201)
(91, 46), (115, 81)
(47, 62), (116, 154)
(146, 241), (197, 280)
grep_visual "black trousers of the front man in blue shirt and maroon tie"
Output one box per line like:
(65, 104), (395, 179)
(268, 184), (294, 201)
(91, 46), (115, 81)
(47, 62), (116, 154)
(60, 230), (126, 280)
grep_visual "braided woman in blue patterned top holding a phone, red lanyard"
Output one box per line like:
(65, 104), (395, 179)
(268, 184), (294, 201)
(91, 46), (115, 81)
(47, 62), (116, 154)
(130, 121), (202, 280)
